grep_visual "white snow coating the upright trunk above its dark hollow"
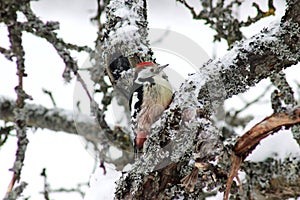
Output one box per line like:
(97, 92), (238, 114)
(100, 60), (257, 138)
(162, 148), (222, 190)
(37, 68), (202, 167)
(103, 0), (149, 57)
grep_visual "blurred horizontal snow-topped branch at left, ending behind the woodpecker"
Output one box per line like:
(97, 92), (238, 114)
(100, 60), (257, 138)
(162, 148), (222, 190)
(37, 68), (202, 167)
(0, 96), (133, 169)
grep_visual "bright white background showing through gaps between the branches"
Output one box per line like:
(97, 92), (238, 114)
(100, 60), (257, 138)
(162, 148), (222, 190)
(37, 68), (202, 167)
(0, 0), (300, 200)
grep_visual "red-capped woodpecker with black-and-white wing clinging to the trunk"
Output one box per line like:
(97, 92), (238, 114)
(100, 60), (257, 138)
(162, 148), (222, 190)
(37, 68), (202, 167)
(129, 62), (173, 153)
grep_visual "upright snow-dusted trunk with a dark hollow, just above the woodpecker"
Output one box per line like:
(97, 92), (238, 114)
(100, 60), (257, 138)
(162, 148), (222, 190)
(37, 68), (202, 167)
(90, 0), (153, 84)
